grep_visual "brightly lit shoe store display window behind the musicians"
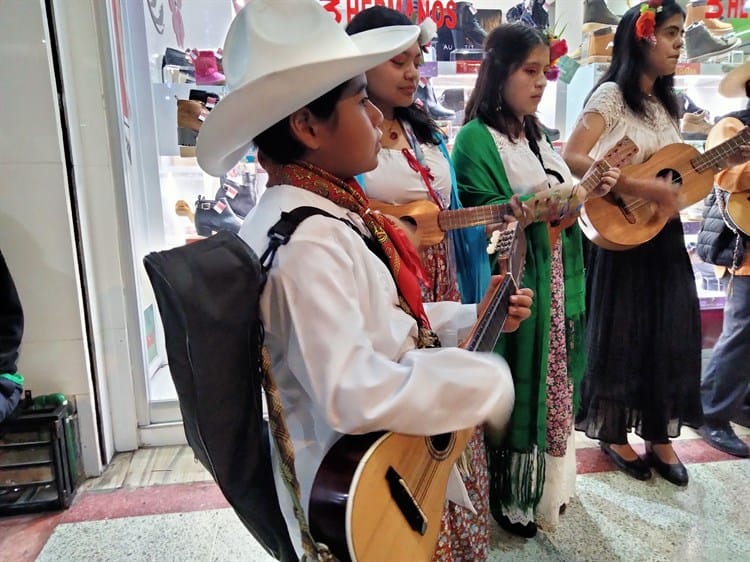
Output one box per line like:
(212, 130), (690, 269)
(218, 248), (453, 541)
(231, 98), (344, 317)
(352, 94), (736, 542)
(111, 0), (743, 423)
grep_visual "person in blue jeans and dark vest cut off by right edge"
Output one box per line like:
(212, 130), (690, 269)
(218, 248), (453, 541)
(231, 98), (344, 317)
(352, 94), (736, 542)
(698, 63), (750, 457)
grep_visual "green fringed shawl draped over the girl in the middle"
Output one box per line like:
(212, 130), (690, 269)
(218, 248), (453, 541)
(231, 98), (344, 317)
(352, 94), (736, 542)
(451, 119), (585, 513)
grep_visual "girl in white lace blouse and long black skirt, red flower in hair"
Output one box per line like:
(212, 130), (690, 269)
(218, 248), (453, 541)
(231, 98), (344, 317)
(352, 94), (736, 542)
(564, 0), (702, 486)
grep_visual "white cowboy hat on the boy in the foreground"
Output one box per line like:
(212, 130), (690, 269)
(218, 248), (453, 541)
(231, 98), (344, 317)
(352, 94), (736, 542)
(197, 0), (419, 176)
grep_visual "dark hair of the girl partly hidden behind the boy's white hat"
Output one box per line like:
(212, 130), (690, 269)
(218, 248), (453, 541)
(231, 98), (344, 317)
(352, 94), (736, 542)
(346, 6), (442, 144)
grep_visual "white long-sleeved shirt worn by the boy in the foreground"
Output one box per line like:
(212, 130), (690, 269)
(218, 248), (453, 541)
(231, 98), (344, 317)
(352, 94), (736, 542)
(240, 185), (514, 555)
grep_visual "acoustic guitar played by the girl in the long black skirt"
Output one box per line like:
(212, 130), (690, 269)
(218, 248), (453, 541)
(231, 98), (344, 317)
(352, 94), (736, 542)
(578, 127), (750, 250)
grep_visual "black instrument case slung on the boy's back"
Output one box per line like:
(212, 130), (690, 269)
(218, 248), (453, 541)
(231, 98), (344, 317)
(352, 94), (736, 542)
(143, 207), (331, 561)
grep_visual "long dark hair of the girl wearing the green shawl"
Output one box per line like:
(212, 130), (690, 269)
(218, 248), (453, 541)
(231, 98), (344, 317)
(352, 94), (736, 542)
(464, 23), (549, 142)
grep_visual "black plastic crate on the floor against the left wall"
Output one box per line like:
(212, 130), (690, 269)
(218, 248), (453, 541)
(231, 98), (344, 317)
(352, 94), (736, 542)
(0, 405), (82, 515)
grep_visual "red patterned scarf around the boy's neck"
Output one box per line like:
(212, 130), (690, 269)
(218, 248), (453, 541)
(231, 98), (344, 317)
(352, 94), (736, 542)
(276, 161), (439, 347)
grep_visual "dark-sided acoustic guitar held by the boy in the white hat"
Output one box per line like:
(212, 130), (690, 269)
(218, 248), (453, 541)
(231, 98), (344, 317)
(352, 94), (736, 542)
(308, 222), (526, 562)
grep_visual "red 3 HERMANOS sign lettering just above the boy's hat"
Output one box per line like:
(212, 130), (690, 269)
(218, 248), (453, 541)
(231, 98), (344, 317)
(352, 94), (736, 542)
(320, 0), (457, 29)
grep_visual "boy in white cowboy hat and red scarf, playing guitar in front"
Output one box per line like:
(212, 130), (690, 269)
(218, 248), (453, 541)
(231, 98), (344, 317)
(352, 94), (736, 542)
(198, 0), (531, 555)
